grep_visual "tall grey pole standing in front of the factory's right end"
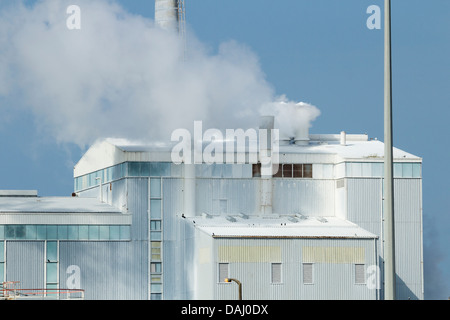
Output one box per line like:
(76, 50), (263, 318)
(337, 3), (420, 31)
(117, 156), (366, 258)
(384, 0), (396, 300)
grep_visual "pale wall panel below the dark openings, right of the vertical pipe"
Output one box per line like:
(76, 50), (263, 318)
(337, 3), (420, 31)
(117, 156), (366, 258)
(273, 178), (335, 216)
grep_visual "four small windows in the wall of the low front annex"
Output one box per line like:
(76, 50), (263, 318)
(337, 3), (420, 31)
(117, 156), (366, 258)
(218, 263), (366, 284)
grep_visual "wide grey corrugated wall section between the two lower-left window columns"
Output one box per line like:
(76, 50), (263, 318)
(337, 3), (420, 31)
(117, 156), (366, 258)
(59, 241), (149, 300)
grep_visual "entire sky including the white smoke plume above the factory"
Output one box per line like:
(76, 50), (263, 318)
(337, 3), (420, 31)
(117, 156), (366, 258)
(0, 0), (450, 299)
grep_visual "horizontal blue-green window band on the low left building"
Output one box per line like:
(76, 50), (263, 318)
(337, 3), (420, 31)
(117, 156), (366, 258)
(0, 225), (131, 240)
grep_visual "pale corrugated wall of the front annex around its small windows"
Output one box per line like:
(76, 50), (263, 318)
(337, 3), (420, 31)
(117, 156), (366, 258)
(211, 239), (378, 300)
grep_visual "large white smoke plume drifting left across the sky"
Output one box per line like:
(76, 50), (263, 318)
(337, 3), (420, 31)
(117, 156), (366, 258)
(0, 0), (316, 146)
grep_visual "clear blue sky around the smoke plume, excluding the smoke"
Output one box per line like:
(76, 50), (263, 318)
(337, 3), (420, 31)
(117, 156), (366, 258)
(0, 0), (450, 299)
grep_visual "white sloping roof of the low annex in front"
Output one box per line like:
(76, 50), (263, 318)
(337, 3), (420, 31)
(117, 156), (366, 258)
(186, 215), (377, 239)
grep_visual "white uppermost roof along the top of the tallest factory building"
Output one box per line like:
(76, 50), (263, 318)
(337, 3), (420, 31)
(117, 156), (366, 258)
(74, 134), (421, 177)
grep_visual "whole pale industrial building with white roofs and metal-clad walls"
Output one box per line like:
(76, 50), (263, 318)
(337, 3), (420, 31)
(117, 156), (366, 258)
(0, 0), (424, 300)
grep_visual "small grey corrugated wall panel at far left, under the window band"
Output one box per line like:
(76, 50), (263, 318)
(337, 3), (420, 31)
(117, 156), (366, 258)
(6, 241), (45, 289)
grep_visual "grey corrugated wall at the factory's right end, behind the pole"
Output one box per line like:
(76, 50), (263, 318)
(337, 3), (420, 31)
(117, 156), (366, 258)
(346, 178), (423, 299)
